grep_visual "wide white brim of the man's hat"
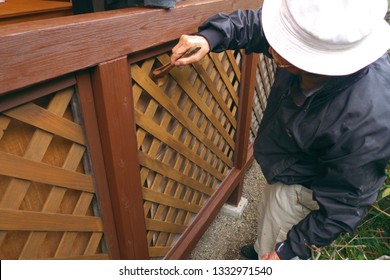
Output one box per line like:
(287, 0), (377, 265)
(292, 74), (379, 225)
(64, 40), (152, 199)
(262, 0), (390, 76)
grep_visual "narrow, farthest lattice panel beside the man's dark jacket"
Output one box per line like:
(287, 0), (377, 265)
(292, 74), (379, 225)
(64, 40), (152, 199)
(250, 54), (276, 142)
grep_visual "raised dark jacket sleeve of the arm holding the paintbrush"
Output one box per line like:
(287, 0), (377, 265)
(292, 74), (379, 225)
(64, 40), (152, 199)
(198, 8), (269, 54)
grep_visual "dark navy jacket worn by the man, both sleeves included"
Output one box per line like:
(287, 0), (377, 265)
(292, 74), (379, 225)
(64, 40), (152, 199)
(199, 9), (390, 259)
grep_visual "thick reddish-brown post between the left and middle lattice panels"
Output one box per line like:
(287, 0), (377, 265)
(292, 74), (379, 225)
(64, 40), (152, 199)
(92, 56), (149, 259)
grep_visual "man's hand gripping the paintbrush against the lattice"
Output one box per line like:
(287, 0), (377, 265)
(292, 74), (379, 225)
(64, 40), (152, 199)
(171, 35), (210, 66)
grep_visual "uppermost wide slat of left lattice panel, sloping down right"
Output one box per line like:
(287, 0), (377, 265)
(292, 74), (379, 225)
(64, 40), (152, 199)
(3, 103), (85, 145)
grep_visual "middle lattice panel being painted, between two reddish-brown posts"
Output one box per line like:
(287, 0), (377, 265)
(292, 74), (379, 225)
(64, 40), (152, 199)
(131, 51), (241, 258)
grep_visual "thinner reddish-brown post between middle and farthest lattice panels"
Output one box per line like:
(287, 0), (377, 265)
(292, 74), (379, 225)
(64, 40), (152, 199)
(227, 54), (259, 206)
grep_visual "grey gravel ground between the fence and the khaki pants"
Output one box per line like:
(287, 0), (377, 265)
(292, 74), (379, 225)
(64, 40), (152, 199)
(188, 162), (265, 260)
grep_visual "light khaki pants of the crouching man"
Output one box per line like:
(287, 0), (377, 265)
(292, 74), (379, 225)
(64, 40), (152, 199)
(255, 183), (319, 258)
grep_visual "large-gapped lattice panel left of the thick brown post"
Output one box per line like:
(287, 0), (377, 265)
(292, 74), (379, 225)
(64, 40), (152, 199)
(0, 87), (108, 259)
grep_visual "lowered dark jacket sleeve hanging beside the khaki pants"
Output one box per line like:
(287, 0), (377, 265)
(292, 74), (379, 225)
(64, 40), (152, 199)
(278, 161), (386, 259)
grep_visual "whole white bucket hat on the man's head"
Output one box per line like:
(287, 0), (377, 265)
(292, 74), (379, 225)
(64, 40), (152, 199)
(262, 0), (390, 76)
